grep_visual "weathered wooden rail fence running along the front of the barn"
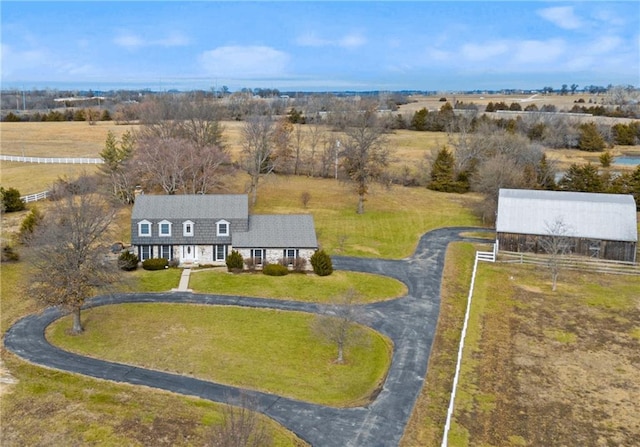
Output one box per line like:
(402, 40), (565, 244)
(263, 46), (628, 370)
(497, 251), (640, 275)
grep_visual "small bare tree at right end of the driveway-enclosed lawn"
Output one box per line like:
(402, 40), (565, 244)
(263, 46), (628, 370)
(312, 289), (368, 363)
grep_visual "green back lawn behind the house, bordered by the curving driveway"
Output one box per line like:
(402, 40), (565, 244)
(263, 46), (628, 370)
(249, 177), (481, 259)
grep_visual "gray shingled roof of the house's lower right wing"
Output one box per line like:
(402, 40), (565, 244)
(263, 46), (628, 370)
(231, 214), (318, 248)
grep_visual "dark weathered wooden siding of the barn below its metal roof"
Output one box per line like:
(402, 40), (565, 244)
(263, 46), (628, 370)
(498, 233), (636, 262)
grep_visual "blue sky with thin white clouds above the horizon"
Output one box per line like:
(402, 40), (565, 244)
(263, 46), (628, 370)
(0, 0), (640, 91)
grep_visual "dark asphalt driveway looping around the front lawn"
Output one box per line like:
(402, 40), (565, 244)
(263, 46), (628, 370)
(4, 227), (486, 447)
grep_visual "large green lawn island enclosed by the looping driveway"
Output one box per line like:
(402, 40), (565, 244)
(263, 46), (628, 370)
(47, 304), (392, 407)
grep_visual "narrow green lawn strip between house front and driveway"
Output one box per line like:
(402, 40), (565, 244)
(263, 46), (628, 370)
(188, 269), (407, 303)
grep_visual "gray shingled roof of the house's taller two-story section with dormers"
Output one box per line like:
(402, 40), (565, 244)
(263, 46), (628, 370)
(131, 194), (249, 220)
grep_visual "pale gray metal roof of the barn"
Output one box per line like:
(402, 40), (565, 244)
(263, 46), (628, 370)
(496, 189), (638, 242)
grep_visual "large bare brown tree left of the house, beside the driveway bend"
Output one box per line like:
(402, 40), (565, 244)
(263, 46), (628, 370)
(29, 182), (115, 333)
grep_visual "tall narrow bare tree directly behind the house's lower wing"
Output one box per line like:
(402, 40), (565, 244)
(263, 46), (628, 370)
(242, 115), (276, 205)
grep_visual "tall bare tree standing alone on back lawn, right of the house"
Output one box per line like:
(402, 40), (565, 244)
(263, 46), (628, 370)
(340, 111), (390, 214)
